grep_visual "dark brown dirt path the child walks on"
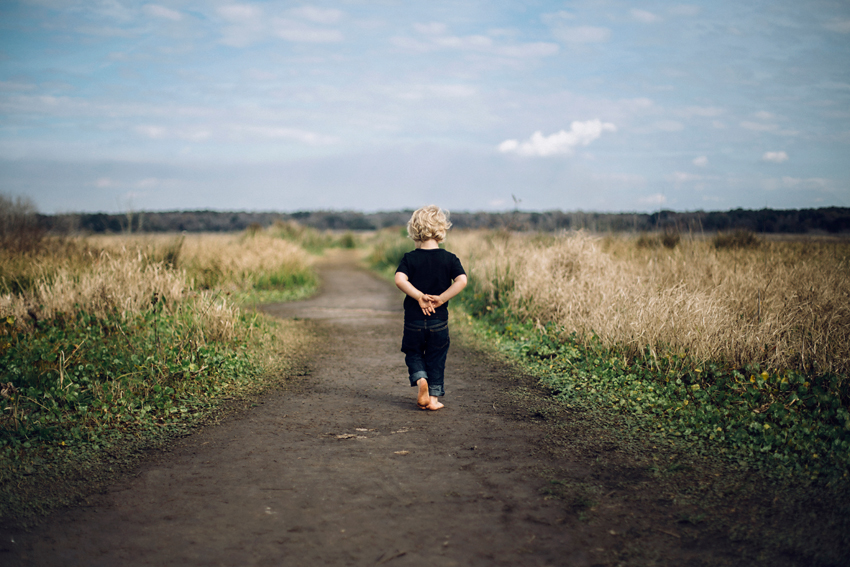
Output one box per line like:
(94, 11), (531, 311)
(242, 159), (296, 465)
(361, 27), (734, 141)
(0, 253), (850, 566)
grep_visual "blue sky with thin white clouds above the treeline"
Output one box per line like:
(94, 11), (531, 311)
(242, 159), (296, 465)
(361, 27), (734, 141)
(0, 0), (850, 213)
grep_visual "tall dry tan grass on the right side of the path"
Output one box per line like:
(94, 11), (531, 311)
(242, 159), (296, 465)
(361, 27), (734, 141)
(450, 232), (850, 374)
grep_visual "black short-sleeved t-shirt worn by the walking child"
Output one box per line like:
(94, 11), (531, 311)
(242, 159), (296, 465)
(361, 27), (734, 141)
(396, 248), (466, 321)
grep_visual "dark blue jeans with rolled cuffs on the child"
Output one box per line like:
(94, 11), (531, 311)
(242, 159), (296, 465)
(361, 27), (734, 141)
(401, 319), (450, 396)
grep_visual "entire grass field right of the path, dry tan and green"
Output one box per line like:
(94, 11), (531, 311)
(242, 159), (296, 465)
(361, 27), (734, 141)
(372, 231), (850, 479)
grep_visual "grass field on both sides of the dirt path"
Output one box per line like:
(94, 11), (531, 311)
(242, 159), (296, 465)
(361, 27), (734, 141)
(6, 223), (850, 524)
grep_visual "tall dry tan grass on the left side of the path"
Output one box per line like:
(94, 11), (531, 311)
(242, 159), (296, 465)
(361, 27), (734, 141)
(0, 234), (311, 339)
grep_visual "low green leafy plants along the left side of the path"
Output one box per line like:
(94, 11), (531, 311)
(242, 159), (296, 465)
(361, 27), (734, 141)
(0, 306), (255, 464)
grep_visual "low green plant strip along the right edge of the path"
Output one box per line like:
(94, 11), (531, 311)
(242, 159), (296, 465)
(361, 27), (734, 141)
(454, 285), (850, 482)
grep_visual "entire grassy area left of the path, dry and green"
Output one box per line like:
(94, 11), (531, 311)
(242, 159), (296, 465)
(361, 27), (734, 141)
(0, 227), (317, 518)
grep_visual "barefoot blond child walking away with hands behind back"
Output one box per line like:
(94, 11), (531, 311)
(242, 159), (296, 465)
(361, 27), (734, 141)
(395, 205), (467, 411)
